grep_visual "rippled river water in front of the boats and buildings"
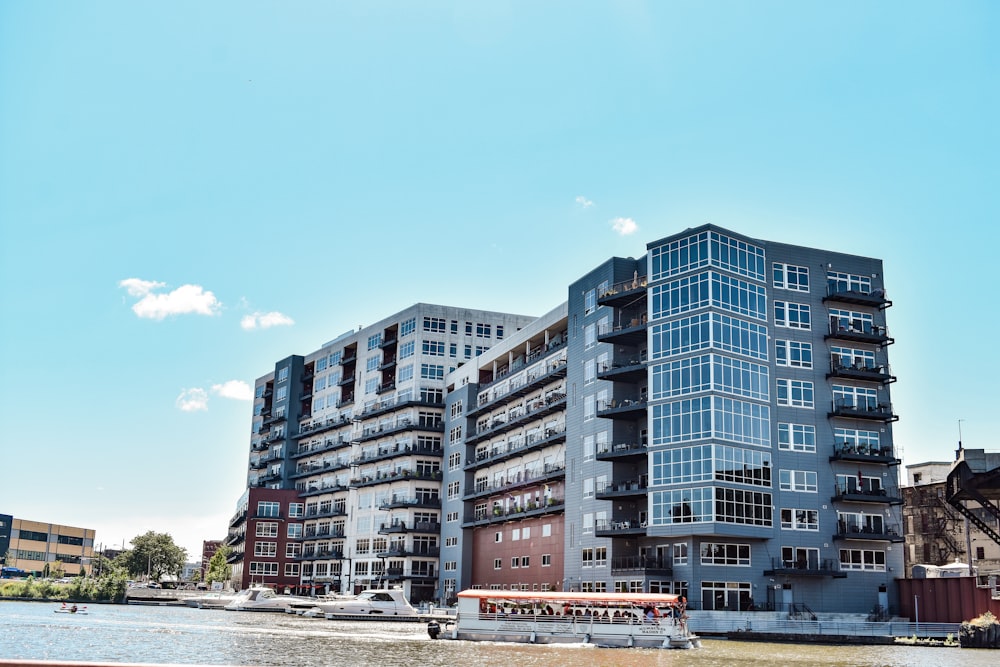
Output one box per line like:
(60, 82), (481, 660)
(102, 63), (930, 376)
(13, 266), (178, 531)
(0, 602), (1000, 667)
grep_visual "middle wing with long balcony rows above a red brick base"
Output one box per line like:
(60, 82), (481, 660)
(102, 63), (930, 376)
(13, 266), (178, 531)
(441, 304), (568, 603)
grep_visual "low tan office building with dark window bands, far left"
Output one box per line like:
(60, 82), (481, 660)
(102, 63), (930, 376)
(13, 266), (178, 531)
(0, 514), (94, 577)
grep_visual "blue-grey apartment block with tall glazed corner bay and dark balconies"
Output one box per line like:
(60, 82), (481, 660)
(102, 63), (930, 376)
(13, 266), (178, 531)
(565, 225), (903, 612)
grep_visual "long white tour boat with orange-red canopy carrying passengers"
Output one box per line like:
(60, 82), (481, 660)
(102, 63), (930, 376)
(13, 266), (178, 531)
(438, 590), (701, 648)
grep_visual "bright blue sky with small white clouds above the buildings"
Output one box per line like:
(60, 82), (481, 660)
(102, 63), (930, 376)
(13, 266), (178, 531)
(0, 0), (1000, 555)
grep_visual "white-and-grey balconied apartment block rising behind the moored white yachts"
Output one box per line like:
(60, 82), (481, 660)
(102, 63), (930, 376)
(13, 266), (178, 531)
(230, 304), (535, 602)
